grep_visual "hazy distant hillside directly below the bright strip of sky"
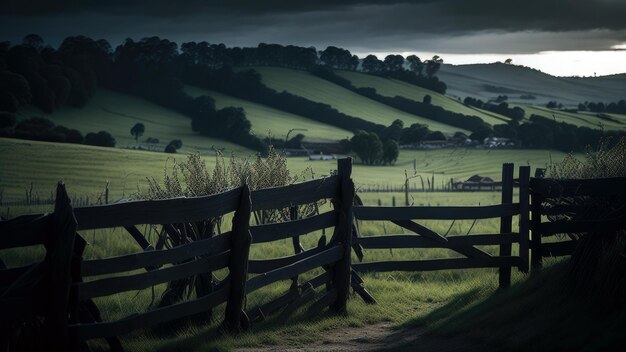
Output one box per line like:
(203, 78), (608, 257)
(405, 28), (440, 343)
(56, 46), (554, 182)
(437, 63), (626, 106)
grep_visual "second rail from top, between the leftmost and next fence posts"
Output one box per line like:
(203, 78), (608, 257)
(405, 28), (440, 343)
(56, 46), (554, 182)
(81, 232), (231, 276)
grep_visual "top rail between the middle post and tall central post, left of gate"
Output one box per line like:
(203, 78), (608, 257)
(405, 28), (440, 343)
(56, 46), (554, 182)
(250, 176), (339, 210)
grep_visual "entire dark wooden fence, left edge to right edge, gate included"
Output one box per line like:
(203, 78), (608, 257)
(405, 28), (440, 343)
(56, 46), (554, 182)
(0, 159), (626, 351)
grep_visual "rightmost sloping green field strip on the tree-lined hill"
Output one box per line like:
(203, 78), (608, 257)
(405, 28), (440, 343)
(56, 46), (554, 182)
(335, 71), (510, 125)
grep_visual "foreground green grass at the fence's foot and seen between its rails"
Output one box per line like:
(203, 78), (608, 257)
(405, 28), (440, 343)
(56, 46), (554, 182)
(0, 184), (524, 351)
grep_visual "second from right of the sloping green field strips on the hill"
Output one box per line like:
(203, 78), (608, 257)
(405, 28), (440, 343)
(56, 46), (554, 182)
(246, 67), (466, 133)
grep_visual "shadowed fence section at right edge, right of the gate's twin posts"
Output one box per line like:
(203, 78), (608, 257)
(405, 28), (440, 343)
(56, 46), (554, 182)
(530, 171), (626, 270)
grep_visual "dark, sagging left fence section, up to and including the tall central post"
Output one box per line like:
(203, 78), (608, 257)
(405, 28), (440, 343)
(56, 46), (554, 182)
(0, 159), (354, 351)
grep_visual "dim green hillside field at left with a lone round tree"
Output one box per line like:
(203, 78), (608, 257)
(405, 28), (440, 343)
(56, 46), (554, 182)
(20, 89), (254, 154)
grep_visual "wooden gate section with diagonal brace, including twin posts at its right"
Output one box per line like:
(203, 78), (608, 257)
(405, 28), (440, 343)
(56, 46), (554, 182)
(352, 164), (530, 287)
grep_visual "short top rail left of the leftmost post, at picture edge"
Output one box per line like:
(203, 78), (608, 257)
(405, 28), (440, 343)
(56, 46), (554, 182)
(0, 214), (52, 249)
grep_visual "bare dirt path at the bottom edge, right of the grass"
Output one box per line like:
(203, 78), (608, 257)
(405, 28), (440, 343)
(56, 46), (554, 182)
(236, 323), (485, 352)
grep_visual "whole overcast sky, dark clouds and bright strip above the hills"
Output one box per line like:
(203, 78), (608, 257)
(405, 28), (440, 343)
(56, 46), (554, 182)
(0, 0), (626, 76)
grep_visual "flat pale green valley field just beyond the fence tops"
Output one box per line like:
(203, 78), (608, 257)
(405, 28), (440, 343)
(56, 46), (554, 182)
(0, 138), (564, 201)
